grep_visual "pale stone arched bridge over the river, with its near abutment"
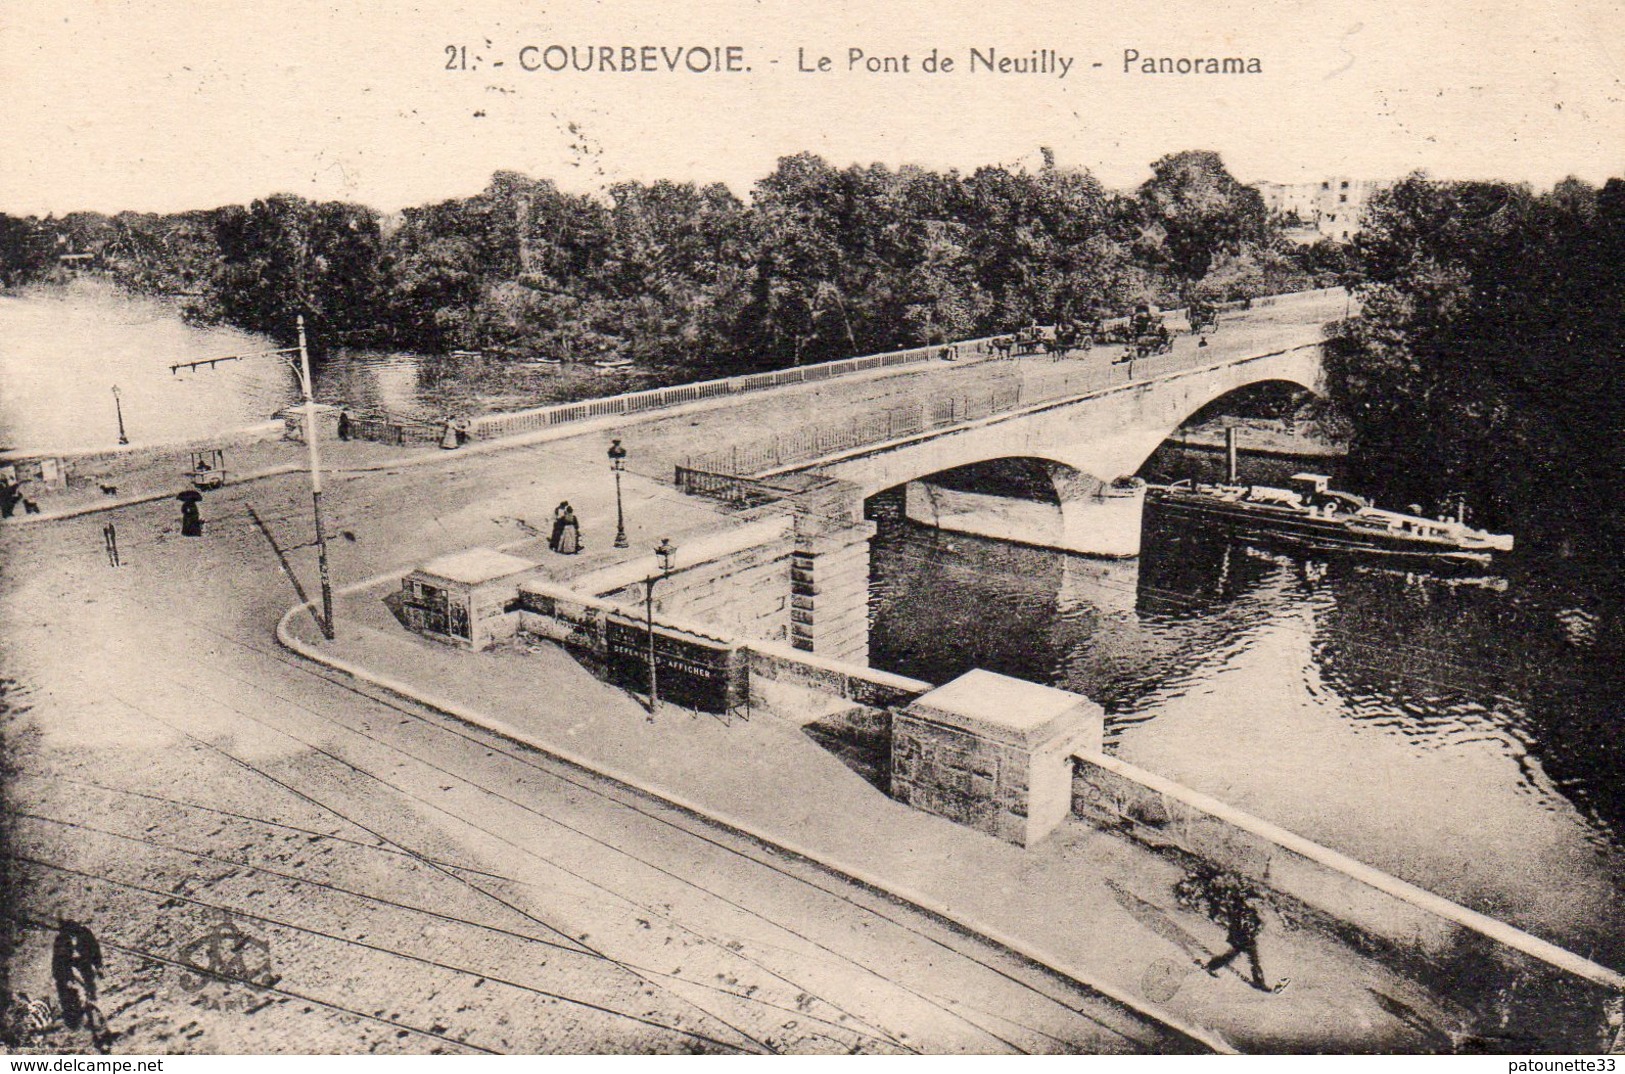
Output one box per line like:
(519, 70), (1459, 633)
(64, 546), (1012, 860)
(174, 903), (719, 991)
(653, 292), (1346, 663)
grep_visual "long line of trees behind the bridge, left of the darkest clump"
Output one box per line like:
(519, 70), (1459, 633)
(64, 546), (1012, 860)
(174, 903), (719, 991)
(0, 151), (1342, 374)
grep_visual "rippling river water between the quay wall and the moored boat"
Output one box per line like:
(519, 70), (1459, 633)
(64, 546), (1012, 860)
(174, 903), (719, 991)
(869, 447), (1625, 968)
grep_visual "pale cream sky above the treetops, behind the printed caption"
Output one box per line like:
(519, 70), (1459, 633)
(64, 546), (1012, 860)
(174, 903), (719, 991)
(0, 0), (1625, 214)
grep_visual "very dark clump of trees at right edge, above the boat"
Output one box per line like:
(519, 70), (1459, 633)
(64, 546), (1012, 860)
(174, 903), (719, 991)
(1331, 175), (1625, 562)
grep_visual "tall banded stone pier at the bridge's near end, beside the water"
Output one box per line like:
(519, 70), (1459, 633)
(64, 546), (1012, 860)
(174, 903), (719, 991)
(790, 479), (876, 665)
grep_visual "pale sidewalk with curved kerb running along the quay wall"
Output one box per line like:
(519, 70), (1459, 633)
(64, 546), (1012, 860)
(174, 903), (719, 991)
(286, 548), (1461, 1051)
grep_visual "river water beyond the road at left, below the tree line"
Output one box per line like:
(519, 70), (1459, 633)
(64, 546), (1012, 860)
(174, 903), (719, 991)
(0, 279), (652, 453)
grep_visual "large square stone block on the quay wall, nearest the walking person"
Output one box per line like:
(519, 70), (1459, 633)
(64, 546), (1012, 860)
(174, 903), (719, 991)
(892, 669), (1105, 847)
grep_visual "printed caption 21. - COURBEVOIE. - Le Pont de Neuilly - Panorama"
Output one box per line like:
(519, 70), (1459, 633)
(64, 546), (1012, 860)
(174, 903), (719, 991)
(481, 42), (1264, 78)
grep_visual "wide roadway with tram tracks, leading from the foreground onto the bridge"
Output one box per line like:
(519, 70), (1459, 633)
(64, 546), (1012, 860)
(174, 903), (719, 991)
(0, 289), (1345, 1051)
